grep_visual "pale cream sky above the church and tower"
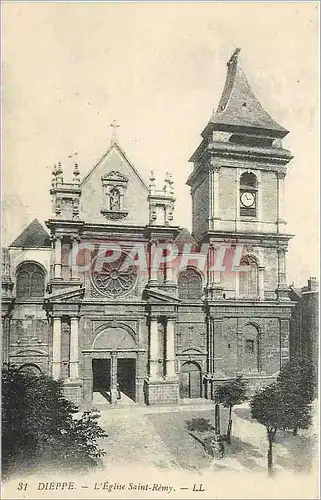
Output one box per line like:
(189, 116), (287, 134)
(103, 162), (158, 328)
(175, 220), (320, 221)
(2, 2), (319, 286)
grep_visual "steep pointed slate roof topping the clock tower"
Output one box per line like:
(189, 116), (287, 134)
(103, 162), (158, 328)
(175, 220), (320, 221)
(202, 49), (288, 137)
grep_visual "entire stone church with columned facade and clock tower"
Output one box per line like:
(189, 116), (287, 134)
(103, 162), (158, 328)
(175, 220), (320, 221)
(2, 49), (293, 405)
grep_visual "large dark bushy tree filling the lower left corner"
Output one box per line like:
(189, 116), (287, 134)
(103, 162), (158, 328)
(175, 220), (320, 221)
(2, 366), (107, 475)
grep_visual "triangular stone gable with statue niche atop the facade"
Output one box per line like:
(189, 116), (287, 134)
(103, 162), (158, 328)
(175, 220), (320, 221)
(80, 144), (148, 226)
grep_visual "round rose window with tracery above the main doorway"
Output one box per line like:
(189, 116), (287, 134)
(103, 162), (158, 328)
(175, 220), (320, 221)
(92, 254), (137, 298)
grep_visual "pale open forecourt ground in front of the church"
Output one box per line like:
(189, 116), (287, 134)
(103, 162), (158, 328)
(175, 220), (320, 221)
(97, 400), (317, 473)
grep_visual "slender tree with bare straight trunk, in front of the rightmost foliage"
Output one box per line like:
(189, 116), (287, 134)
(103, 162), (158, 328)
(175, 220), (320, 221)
(250, 383), (283, 475)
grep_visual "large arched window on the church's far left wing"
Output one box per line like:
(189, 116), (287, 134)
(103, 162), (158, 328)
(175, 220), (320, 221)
(17, 262), (45, 298)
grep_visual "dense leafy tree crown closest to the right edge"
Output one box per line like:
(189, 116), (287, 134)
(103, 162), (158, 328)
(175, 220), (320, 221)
(277, 358), (315, 435)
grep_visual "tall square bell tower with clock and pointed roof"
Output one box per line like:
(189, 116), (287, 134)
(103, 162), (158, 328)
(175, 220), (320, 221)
(187, 49), (292, 398)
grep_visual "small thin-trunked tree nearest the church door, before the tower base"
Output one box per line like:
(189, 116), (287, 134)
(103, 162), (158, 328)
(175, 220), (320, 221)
(214, 376), (247, 444)
